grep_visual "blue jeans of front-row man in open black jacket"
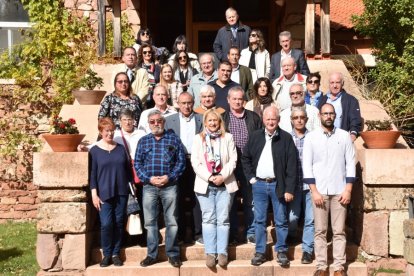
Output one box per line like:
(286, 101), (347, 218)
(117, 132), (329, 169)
(252, 180), (288, 254)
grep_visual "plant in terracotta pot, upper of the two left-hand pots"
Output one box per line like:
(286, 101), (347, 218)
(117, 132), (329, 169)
(72, 68), (106, 104)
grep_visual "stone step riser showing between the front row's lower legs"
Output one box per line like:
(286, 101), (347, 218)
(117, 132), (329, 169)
(91, 242), (358, 264)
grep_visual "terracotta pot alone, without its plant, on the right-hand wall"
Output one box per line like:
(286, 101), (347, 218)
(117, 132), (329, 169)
(361, 130), (401, 149)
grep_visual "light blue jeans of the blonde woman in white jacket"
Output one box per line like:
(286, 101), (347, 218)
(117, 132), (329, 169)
(196, 185), (234, 255)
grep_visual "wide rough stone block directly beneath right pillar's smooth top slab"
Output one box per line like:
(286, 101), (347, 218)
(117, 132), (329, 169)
(363, 185), (414, 211)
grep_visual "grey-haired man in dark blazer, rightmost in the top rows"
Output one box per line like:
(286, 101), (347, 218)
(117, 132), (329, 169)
(269, 31), (310, 82)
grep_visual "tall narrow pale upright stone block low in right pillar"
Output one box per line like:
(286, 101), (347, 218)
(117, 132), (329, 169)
(389, 211), (408, 256)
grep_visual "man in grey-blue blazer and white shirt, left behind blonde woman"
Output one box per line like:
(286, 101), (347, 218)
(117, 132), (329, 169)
(165, 92), (203, 244)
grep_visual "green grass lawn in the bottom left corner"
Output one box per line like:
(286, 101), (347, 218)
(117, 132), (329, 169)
(0, 222), (39, 276)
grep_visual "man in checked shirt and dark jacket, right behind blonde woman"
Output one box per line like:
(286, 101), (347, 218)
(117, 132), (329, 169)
(223, 86), (262, 244)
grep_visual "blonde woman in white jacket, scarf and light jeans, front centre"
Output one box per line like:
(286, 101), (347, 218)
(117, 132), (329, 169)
(191, 109), (238, 268)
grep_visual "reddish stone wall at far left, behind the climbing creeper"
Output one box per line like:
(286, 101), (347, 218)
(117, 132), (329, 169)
(0, 80), (49, 223)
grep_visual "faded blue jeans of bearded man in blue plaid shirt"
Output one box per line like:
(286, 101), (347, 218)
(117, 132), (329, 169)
(142, 184), (180, 259)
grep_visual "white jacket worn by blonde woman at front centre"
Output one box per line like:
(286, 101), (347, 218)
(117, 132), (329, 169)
(191, 133), (239, 194)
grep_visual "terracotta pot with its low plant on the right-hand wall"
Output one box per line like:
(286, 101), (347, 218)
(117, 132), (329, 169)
(361, 120), (401, 149)
